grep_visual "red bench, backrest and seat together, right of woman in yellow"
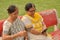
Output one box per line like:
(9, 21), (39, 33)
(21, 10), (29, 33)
(40, 9), (60, 40)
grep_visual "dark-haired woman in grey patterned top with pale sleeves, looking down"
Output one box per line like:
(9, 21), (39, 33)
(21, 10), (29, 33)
(2, 5), (26, 40)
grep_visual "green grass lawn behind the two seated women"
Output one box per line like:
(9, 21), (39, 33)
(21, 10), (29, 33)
(0, 0), (60, 32)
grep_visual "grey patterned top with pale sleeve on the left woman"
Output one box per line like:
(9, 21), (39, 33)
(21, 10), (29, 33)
(3, 18), (25, 40)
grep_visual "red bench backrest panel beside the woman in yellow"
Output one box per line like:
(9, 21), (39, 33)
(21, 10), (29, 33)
(40, 10), (57, 27)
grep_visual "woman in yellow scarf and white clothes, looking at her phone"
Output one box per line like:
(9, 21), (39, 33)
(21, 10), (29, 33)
(22, 3), (52, 40)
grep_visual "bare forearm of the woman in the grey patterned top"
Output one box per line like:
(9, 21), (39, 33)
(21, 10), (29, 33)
(2, 31), (26, 40)
